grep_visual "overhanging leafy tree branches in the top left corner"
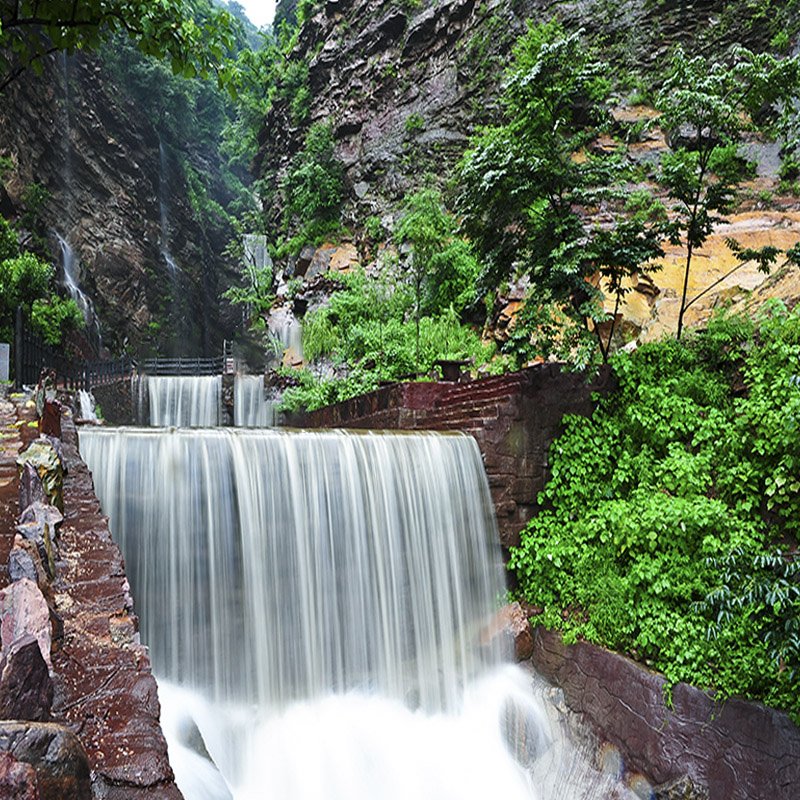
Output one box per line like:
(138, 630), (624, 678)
(0, 0), (234, 92)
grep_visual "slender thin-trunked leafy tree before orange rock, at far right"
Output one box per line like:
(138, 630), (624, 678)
(656, 48), (800, 339)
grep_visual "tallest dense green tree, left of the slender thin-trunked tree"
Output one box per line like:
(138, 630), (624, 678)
(457, 21), (663, 366)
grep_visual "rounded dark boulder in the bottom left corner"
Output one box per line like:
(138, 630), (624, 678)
(0, 721), (92, 800)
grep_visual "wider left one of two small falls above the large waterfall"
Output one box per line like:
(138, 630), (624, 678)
(131, 375), (222, 428)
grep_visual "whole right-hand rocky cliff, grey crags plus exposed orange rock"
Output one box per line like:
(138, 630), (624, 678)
(255, 0), (800, 350)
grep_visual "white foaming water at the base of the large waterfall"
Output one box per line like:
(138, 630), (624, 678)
(159, 665), (640, 800)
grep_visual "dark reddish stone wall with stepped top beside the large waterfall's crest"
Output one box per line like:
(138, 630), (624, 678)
(300, 364), (612, 549)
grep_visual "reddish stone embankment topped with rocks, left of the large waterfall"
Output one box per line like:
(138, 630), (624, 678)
(0, 384), (181, 800)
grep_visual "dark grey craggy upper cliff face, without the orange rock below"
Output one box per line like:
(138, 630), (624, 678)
(255, 0), (780, 230)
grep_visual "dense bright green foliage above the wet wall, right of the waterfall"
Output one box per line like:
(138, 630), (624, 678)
(509, 304), (800, 719)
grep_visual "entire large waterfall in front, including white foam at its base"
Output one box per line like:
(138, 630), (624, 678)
(80, 429), (636, 800)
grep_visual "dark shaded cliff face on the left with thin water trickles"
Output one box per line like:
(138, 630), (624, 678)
(0, 55), (238, 353)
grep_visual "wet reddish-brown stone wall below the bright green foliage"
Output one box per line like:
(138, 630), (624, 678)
(532, 628), (800, 800)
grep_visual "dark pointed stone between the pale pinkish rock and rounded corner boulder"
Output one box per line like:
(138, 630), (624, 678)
(0, 633), (53, 722)
